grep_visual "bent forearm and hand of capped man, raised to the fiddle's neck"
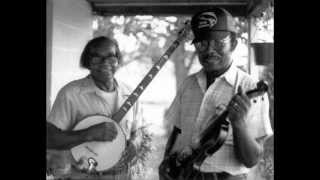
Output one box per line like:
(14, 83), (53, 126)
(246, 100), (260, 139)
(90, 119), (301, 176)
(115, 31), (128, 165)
(229, 87), (269, 168)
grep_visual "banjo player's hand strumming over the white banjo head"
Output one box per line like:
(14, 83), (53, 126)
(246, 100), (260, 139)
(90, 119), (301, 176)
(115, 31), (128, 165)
(86, 122), (118, 141)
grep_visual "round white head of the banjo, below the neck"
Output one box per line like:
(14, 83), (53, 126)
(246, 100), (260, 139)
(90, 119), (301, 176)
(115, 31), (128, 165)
(71, 115), (126, 171)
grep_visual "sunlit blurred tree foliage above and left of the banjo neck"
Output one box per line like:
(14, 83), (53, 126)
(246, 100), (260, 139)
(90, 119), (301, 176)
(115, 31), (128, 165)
(94, 16), (191, 63)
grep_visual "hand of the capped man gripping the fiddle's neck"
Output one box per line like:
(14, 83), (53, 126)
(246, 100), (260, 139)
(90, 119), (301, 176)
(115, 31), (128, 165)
(228, 87), (251, 125)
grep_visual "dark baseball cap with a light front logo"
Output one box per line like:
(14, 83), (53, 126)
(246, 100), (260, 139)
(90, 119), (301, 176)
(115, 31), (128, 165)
(191, 7), (237, 43)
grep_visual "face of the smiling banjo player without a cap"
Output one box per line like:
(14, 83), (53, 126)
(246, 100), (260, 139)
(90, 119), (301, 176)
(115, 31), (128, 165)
(89, 44), (119, 82)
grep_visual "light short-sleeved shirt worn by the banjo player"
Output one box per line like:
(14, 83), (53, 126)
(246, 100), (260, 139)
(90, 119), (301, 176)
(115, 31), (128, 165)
(47, 76), (142, 179)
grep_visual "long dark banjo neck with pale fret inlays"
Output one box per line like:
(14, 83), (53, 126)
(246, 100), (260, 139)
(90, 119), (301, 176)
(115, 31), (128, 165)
(112, 21), (190, 122)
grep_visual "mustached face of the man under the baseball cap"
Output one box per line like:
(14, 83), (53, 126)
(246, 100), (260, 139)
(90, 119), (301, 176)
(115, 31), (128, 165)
(194, 31), (233, 72)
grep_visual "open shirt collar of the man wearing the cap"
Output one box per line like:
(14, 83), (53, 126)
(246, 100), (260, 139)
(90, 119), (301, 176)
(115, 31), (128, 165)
(196, 63), (237, 92)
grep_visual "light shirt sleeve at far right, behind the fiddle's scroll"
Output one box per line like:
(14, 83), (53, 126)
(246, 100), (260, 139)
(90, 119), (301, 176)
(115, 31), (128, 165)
(248, 93), (273, 139)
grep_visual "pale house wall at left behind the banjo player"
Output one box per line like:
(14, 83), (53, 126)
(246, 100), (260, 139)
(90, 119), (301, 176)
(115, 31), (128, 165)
(47, 0), (93, 114)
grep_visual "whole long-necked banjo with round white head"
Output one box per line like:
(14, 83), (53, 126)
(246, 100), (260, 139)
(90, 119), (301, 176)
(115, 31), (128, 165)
(71, 20), (190, 173)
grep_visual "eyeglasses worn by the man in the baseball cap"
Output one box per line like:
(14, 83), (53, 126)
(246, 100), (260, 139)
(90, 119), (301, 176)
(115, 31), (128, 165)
(194, 36), (231, 52)
